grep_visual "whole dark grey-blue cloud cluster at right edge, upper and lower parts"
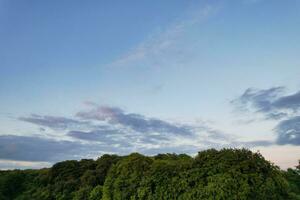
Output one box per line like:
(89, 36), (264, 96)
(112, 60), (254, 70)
(231, 87), (300, 146)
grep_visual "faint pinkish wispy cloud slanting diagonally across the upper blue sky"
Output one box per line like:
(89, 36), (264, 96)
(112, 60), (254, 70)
(109, 4), (218, 67)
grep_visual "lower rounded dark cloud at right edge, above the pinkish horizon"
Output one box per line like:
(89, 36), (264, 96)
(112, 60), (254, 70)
(275, 116), (300, 145)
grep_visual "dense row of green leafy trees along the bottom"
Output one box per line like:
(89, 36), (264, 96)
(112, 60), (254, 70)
(0, 149), (300, 200)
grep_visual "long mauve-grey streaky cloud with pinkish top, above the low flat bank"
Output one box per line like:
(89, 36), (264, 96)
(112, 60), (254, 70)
(20, 105), (228, 155)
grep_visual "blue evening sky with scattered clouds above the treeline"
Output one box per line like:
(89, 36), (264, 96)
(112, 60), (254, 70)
(0, 0), (300, 169)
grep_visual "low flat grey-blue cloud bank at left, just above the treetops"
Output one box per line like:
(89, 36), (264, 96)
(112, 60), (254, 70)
(0, 135), (132, 163)
